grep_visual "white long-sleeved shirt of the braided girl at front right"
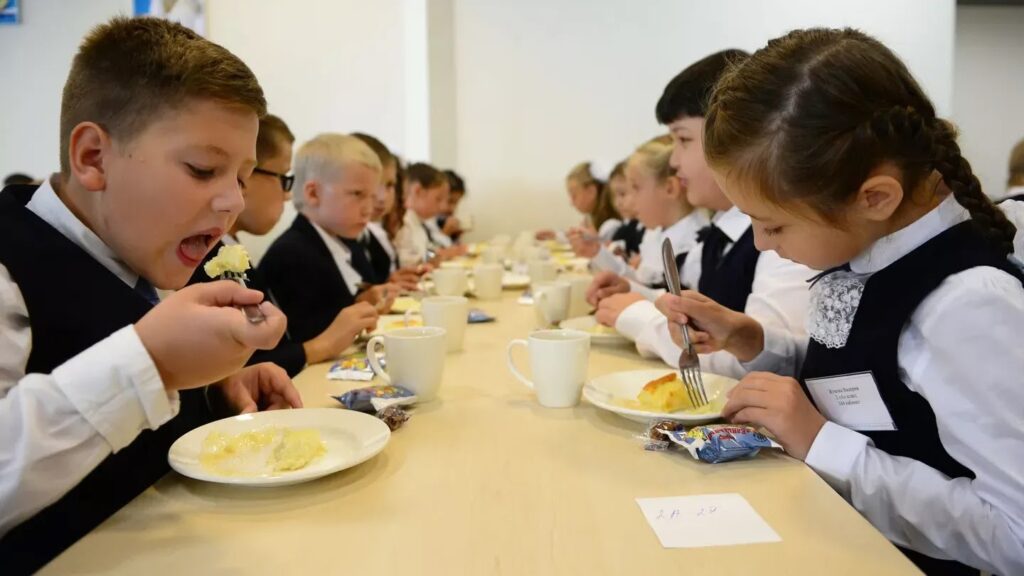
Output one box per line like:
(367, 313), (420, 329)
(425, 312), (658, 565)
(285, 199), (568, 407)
(746, 196), (1024, 574)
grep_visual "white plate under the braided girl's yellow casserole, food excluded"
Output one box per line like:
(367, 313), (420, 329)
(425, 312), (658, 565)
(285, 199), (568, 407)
(583, 368), (736, 424)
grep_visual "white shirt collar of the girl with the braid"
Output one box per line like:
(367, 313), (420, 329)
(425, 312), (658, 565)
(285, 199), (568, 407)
(850, 195), (971, 274)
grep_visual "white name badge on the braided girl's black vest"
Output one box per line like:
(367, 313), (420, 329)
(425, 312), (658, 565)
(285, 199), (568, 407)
(806, 372), (896, 430)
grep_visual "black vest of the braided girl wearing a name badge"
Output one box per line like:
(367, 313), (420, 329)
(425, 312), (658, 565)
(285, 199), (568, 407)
(800, 220), (1024, 575)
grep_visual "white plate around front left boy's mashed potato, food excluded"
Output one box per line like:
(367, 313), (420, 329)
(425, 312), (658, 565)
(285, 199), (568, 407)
(167, 408), (391, 486)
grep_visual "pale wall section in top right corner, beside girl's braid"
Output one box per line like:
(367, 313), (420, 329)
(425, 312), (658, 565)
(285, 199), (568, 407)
(953, 6), (1024, 198)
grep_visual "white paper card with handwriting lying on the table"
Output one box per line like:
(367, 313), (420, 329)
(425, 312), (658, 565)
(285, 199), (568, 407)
(637, 487), (782, 548)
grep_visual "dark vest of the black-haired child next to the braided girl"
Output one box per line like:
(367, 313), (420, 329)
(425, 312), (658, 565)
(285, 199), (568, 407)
(697, 224), (761, 312)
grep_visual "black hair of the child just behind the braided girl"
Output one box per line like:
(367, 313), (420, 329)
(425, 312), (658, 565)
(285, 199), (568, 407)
(654, 48), (750, 124)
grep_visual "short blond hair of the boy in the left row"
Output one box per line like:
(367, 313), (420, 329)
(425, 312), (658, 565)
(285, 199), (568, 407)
(292, 132), (382, 208)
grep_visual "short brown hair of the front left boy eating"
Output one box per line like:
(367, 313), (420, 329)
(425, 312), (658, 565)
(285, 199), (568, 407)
(60, 17), (266, 176)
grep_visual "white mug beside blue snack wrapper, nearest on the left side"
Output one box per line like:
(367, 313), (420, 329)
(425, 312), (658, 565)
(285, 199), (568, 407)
(367, 326), (447, 402)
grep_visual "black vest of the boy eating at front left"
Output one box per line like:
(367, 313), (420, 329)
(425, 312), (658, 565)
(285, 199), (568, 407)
(0, 186), (210, 574)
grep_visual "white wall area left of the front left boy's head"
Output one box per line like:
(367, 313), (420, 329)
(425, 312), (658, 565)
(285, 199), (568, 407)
(0, 0), (132, 178)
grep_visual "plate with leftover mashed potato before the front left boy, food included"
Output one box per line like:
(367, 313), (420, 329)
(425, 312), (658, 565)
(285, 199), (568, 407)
(167, 408), (391, 486)
